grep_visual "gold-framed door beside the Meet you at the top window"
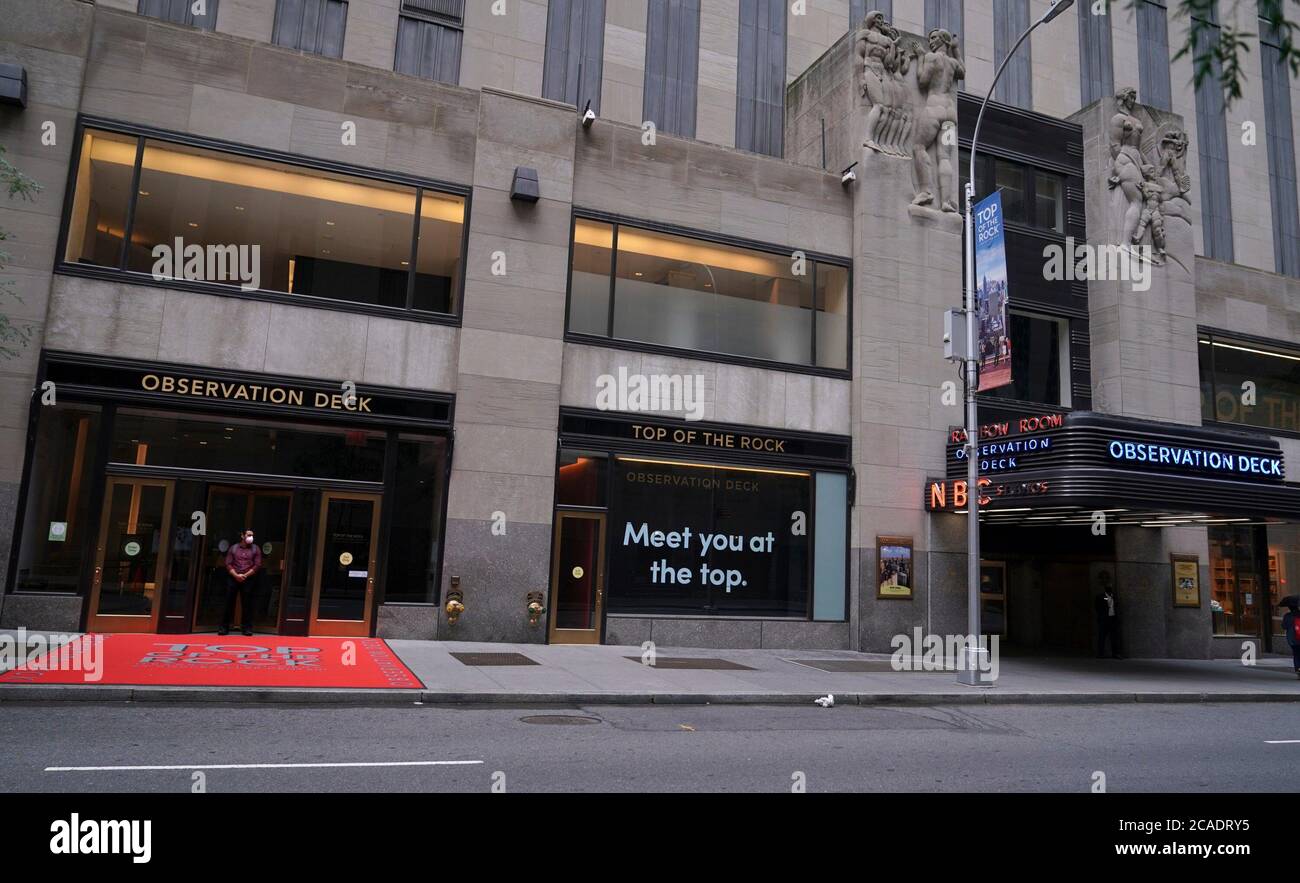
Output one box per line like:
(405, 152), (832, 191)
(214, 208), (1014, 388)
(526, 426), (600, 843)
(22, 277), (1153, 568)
(547, 511), (605, 644)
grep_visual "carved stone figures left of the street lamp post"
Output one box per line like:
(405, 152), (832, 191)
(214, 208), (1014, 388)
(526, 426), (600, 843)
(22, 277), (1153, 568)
(855, 10), (966, 212)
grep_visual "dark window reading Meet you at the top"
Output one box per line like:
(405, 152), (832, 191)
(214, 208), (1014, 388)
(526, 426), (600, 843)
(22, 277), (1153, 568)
(607, 456), (811, 618)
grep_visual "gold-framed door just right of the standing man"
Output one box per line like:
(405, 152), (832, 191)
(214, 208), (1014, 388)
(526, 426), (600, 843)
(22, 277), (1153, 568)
(308, 490), (384, 637)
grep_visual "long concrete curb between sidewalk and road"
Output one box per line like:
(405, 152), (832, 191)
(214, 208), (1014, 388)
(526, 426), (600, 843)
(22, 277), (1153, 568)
(0, 684), (1300, 707)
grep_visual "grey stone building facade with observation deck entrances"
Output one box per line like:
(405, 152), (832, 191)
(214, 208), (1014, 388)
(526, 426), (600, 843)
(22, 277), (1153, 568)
(0, 0), (1300, 658)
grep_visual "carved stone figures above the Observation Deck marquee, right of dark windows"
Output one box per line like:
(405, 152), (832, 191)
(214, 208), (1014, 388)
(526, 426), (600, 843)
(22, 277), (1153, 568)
(1106, 86), (1192, 264)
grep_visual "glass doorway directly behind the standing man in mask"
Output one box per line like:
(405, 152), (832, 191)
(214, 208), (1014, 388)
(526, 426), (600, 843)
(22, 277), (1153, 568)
(194, 488), (291, 632)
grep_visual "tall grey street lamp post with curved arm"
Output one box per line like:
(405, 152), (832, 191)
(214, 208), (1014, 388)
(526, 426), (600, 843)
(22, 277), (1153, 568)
(957, 0), (1074, 687)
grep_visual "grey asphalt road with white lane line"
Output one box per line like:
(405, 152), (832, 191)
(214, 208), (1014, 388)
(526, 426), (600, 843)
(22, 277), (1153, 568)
(0, 702), (1300, 793)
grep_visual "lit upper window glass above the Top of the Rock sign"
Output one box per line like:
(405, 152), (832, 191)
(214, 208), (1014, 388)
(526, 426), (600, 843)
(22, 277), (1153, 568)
(568, 218), (849, 369)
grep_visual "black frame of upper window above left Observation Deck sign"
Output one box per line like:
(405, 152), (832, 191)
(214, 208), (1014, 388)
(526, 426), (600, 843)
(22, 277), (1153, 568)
(53, 114), (473, 325)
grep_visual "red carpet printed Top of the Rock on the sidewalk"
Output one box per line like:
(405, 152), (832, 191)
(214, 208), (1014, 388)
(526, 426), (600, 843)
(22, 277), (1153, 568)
(0, 635), (424, 689)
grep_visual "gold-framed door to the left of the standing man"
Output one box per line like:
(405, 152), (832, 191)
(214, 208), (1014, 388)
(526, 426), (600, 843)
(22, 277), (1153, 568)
(86, 476), (176, 633)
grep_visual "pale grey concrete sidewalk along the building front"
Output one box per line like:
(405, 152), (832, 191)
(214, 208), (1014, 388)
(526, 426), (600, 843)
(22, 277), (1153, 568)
(0, 632), (1300, 705)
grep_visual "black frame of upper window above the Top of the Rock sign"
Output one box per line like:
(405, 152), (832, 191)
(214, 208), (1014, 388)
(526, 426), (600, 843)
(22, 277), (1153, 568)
(564, 207), (854, 380)
